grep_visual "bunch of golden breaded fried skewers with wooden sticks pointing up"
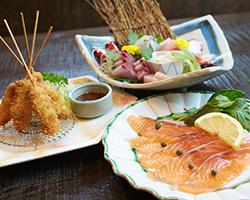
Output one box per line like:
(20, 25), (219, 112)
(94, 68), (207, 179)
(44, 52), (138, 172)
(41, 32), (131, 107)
(0, 11), (72, 135)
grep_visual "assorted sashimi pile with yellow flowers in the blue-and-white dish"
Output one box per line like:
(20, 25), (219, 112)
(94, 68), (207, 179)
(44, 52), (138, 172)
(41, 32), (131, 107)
(93, 30), (216, 83)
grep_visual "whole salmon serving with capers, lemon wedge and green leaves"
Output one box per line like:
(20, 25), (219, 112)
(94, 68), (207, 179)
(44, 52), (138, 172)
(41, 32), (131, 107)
(127, 90), (250, 194)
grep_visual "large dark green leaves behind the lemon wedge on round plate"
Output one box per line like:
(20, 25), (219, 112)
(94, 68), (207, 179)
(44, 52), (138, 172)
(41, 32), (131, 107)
(169, 90), (250, 131)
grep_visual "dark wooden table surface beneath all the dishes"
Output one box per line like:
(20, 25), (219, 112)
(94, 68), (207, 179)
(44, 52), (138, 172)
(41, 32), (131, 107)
(0, 13), (250, 200)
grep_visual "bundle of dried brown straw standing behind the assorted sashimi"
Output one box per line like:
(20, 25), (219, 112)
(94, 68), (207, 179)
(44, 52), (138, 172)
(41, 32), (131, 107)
(86, 0), (175, 45)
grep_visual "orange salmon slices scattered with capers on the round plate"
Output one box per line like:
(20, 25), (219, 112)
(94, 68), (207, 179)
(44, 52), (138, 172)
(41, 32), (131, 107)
(128, 116), (250, 194)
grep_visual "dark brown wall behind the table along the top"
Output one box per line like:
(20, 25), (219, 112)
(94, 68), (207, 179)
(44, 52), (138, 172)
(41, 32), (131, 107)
(0, 0), (250, 36)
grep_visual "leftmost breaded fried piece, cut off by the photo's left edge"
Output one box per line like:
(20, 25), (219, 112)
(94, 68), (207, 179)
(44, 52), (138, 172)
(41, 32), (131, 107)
(0, 83), (15, 126)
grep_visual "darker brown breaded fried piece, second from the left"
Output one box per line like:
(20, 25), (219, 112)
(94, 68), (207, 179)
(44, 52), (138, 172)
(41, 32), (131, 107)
(10, 78), (32, 131)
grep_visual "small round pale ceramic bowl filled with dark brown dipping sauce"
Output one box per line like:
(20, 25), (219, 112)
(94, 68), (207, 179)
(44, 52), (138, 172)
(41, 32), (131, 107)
(69, 82), (113, 118)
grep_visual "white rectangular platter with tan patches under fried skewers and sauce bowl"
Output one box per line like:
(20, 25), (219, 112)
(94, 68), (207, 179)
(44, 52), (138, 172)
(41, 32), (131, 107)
(0, 76), (137, 167)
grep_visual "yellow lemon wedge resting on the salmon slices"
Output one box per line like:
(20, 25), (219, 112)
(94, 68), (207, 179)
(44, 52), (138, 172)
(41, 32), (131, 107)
(194, 112), (244, 149)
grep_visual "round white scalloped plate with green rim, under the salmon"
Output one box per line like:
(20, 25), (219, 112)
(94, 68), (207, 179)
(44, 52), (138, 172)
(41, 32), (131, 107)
(103, 92), (250, 200)
